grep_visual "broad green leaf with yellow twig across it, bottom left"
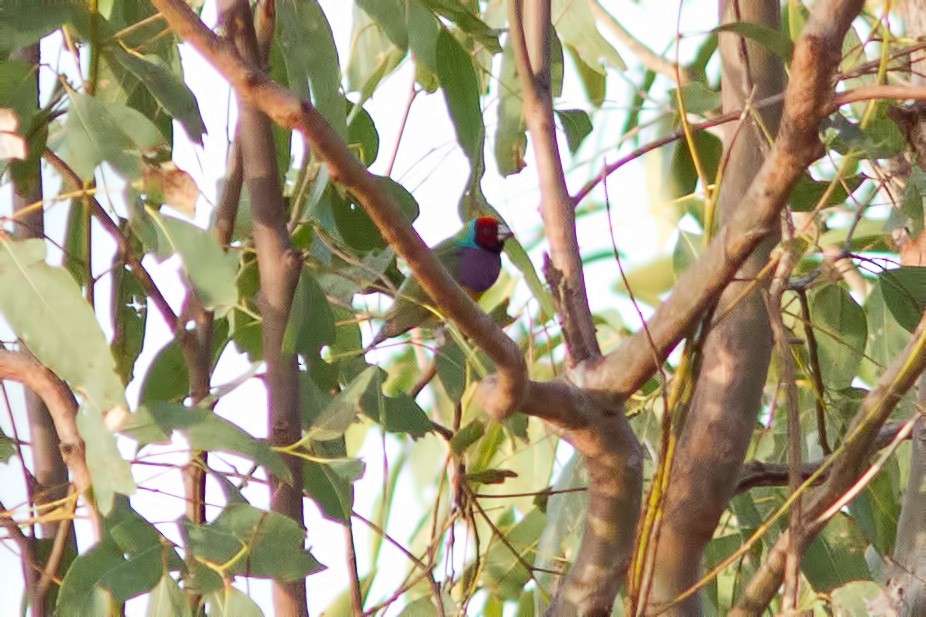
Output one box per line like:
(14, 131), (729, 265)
(183, 503), (324, 581)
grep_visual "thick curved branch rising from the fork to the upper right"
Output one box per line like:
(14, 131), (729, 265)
(583, 0), (863, 400)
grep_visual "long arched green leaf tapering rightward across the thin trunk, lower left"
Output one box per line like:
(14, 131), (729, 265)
(138, 403), (290, 481)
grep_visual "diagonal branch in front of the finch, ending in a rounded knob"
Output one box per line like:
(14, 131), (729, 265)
(152, 0), (527, 414)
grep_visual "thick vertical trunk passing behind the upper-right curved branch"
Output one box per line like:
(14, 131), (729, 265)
(650, 0), (784, 615)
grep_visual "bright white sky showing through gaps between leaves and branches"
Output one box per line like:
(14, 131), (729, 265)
(0, 0), (716, 615)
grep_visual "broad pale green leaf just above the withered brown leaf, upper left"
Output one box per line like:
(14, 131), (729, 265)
(65, 92), (164, 180)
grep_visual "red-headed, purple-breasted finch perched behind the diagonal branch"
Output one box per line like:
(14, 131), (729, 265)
(367, 216), (512, 349)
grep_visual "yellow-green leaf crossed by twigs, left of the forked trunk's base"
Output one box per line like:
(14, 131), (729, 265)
(482, 508), (547, 600)
